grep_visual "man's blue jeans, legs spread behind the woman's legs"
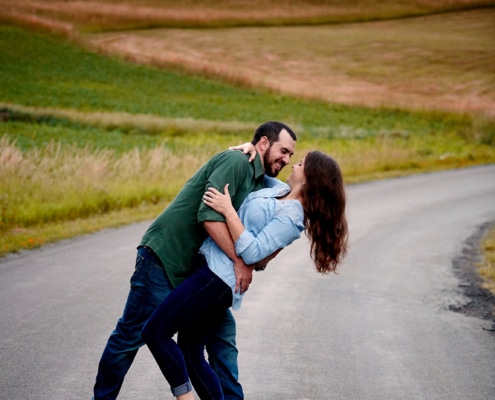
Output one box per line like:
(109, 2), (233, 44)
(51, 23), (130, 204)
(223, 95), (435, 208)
(94, 247), (244, 400)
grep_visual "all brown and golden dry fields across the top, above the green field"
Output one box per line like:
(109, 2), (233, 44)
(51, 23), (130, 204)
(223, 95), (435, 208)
(0, 0), (495, 115)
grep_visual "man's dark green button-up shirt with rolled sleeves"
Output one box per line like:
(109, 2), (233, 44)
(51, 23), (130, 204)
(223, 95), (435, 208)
(140, 150), (264, 287)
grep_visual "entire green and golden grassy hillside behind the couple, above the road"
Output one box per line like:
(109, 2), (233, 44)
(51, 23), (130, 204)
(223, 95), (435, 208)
(0, 0), (495, 294)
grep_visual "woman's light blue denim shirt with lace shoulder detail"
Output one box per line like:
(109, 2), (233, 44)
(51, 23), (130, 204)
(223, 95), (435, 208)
(200, 178), (304, 310)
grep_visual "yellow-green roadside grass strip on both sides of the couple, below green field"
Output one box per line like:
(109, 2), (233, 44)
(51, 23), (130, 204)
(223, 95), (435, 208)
(0, 122), (494, 256)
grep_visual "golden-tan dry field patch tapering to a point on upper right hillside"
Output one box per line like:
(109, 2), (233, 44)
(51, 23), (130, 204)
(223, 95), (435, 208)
(87, 9), (495, 114)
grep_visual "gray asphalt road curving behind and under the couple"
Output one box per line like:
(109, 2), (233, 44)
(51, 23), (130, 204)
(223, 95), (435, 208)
(0, 166), (495, 400)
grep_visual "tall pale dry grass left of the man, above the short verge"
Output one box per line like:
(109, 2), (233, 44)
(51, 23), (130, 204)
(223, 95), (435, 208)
(0, 137), (207, 234)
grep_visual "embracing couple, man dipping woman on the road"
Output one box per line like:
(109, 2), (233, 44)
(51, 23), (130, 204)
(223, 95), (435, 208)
(94, 121), (348, 400)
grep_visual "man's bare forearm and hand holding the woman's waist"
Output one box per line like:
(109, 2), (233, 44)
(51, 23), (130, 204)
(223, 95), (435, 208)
(203, 221), (254, 293)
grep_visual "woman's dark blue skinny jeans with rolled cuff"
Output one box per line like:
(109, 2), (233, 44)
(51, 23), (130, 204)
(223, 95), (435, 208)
(143, 263), (232, 400)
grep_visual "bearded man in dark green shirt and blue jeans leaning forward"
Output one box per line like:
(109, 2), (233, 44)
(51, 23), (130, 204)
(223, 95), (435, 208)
(94, 121), (296, 400)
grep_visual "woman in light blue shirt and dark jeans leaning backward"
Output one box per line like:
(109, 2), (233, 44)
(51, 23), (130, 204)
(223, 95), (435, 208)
(143, 151), (348, 400)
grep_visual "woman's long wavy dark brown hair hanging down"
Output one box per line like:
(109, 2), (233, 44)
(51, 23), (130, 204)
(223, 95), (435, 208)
(302, 151), (349, 274)
